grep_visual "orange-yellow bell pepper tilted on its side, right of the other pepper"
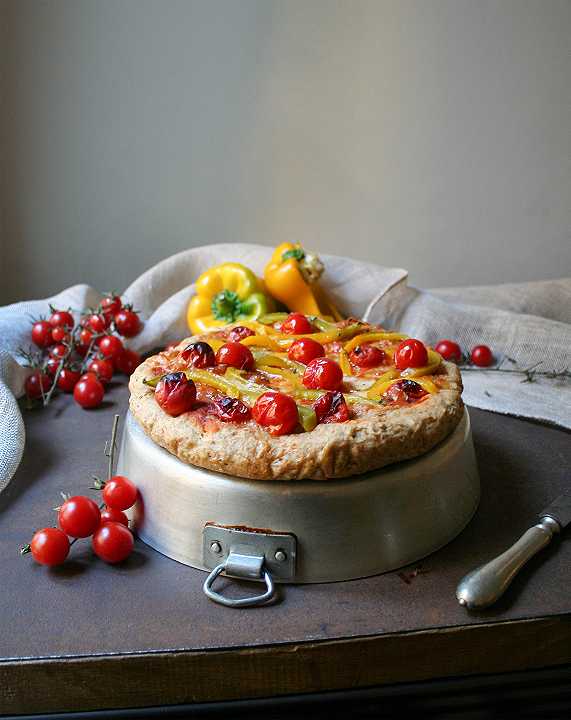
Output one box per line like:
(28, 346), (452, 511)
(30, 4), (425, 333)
(264, 243), (342, 320)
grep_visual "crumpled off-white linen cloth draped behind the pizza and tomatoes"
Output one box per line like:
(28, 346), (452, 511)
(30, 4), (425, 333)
(0, 244), (571, 492)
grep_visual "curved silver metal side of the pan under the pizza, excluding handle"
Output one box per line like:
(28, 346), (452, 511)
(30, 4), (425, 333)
(118, 412), (480, 583)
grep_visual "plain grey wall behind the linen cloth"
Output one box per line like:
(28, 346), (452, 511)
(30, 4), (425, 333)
(0, 0), (571, 301)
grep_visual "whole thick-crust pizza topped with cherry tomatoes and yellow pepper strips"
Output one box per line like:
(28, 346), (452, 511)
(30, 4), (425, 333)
(129, 313), (463, 480)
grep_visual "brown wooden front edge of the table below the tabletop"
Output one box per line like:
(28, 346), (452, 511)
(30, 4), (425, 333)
(0, 614), (571, 714)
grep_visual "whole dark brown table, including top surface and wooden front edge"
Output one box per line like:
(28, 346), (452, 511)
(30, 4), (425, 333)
(0, 385), (571, 713)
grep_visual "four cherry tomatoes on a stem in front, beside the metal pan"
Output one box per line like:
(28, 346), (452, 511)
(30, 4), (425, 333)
(22, 475), (137, 566)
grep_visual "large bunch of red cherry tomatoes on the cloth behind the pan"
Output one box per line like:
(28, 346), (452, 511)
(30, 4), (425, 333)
(22, 295), (142, 409)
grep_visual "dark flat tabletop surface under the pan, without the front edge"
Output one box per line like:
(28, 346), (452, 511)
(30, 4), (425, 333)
(0, 384), (571, 716)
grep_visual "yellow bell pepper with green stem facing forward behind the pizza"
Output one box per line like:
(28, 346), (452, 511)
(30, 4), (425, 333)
(186, 262), (268, 335)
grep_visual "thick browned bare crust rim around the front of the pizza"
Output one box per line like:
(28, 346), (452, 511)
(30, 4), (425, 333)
(129, 341), (463, 480)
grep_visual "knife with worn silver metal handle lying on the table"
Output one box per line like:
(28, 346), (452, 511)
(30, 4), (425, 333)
(456, 492), (571, 610)
